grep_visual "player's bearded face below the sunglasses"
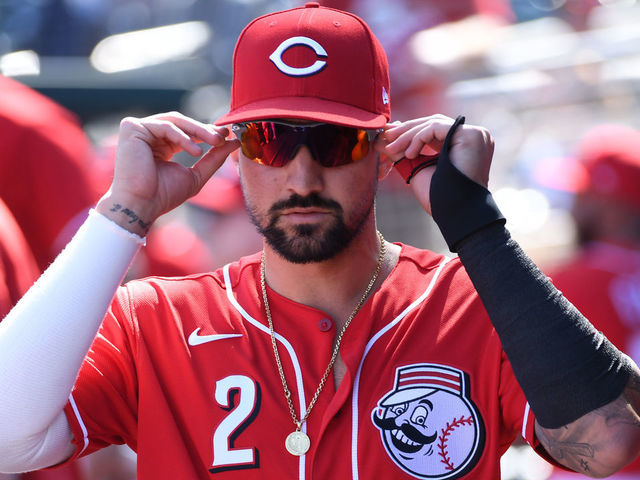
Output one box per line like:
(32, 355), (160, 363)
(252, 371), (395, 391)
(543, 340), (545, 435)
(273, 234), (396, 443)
(239, 127), (378, 263)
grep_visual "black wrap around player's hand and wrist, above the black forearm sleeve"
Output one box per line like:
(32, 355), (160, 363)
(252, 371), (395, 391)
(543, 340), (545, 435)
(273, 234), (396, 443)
(429, 115), (505, 252)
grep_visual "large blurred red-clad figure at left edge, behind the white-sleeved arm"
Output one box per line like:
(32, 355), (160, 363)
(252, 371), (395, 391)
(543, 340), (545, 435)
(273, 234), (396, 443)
(0, 75), (97, 270)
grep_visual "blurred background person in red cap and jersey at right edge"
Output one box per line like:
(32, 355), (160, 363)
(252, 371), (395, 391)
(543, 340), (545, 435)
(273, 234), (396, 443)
(546, 124), (640, 480)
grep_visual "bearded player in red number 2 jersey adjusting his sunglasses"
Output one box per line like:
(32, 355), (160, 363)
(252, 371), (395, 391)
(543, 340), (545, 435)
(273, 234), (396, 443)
(0, 3), (640, 479)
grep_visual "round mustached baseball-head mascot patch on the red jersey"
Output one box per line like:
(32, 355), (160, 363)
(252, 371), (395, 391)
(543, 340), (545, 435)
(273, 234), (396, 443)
(371, 363), (485, 479)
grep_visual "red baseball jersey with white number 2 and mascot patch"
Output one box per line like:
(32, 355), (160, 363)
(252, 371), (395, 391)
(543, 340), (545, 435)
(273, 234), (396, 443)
(60, 245), (536, 480)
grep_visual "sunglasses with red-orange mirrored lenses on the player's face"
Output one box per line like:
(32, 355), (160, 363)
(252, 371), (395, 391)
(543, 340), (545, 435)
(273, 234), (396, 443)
(231, 121), (382, 167)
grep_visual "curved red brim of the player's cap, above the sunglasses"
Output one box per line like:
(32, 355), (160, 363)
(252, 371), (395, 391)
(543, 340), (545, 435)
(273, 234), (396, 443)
(215, 97), (389, 129)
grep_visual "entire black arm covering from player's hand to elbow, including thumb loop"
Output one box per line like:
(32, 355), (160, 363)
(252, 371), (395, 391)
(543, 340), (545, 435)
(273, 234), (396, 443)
(430, 117), (632, 428)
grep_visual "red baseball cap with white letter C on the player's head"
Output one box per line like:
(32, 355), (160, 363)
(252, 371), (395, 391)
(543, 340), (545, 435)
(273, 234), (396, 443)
(216, 2), (391, 129)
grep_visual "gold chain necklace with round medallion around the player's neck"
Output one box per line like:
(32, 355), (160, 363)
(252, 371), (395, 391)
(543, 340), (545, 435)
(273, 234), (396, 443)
(260, 232), (386, 456)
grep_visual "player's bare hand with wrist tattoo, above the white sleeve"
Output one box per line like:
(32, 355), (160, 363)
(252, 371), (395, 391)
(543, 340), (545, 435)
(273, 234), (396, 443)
(96, 112), (240, 236)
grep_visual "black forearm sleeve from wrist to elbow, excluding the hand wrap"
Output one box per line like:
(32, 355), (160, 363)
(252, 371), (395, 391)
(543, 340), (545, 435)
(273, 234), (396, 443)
(458, 223), (632, 428)
